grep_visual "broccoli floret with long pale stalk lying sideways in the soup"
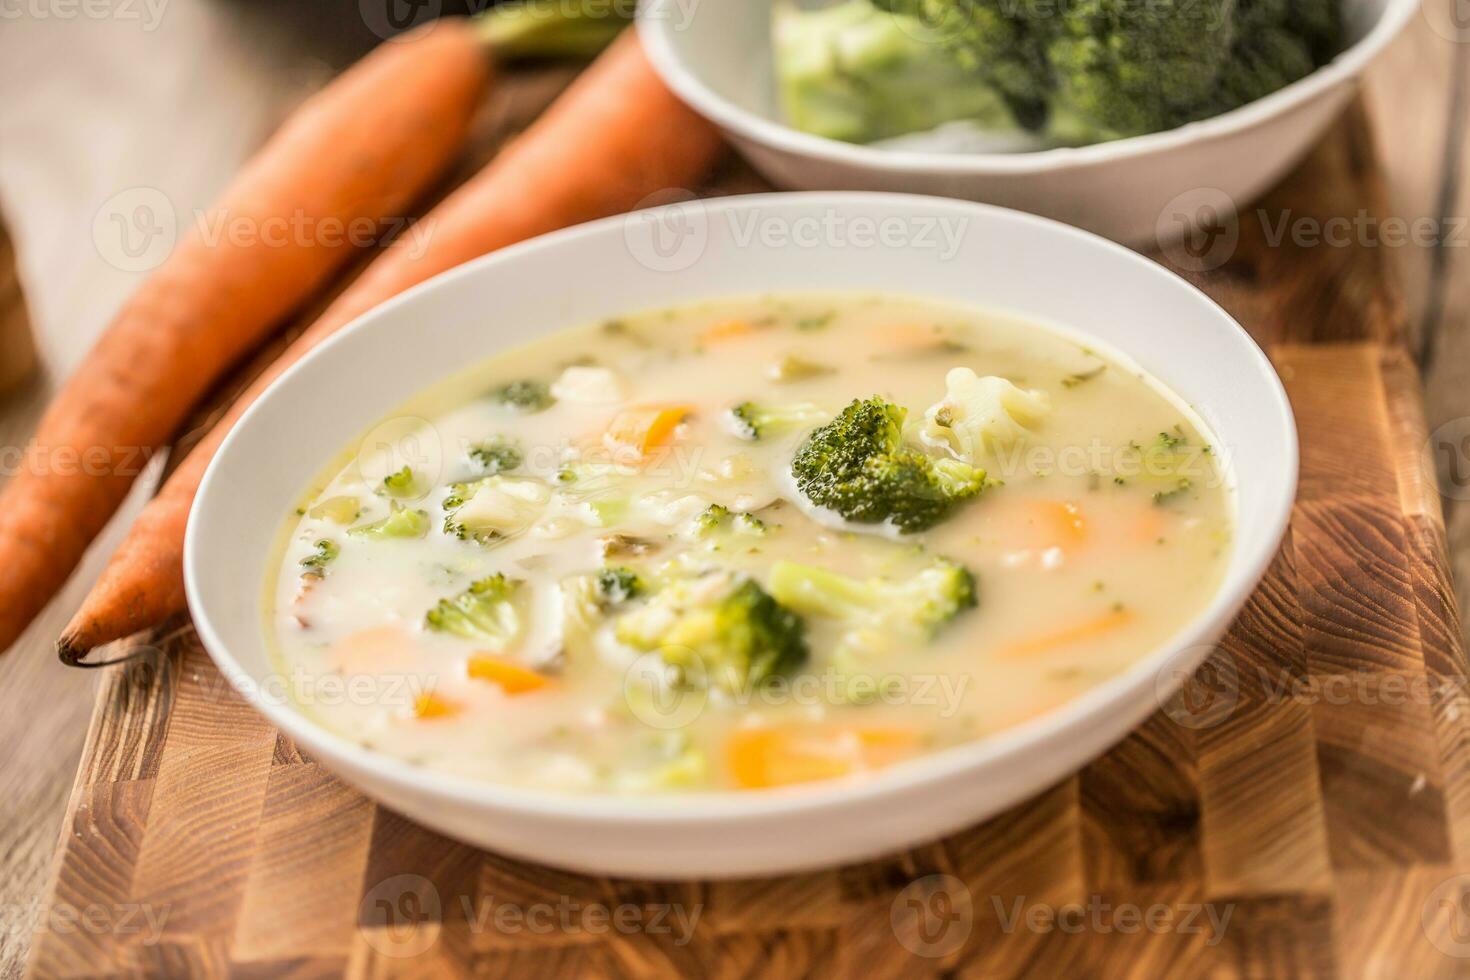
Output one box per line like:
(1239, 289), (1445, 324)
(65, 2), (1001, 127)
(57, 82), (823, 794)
(770, 558), (976, 636)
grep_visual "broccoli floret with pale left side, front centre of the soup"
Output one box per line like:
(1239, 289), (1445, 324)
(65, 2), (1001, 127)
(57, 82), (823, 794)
(614, 572), (807, 693)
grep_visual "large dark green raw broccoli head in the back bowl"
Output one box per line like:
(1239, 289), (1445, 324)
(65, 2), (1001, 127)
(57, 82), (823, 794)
(876, 0), (1342, 143)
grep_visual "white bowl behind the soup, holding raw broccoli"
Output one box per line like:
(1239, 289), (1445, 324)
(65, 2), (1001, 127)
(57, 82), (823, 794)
(638, 0), (1419, 245)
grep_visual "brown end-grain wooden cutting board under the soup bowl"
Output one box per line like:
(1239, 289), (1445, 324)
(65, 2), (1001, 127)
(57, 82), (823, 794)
(29, 72), (1470, 977)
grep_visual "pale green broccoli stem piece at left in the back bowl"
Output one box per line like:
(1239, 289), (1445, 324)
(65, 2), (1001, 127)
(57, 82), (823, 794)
(772, 0), (1019, 143)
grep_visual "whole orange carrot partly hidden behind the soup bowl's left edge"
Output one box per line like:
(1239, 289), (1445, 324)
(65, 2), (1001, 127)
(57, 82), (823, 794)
(57, 34), (720, 663)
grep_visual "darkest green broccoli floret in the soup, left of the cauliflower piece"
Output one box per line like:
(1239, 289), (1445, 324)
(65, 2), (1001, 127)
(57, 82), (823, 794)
(791, 397), (986, 533)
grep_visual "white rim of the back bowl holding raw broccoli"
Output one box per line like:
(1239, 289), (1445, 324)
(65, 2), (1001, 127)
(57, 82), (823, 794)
(637, 0), (1420, 176)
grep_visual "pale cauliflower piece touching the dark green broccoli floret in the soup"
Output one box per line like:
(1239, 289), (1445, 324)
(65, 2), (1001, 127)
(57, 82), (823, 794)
(919, 367), (1051, 463)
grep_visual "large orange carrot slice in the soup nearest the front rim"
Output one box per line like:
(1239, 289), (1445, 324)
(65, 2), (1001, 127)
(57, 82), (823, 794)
(726, 726), (919, 789)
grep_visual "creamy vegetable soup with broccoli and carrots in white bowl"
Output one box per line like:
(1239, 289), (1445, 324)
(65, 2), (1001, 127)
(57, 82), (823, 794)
(268, 294), (1232, 793)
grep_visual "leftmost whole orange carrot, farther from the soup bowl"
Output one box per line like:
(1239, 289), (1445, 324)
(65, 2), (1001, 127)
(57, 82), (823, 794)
(0, 21), (490, 651)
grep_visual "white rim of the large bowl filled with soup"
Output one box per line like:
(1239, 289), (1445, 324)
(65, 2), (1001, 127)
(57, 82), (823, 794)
(184, 191), (1298, 827)
